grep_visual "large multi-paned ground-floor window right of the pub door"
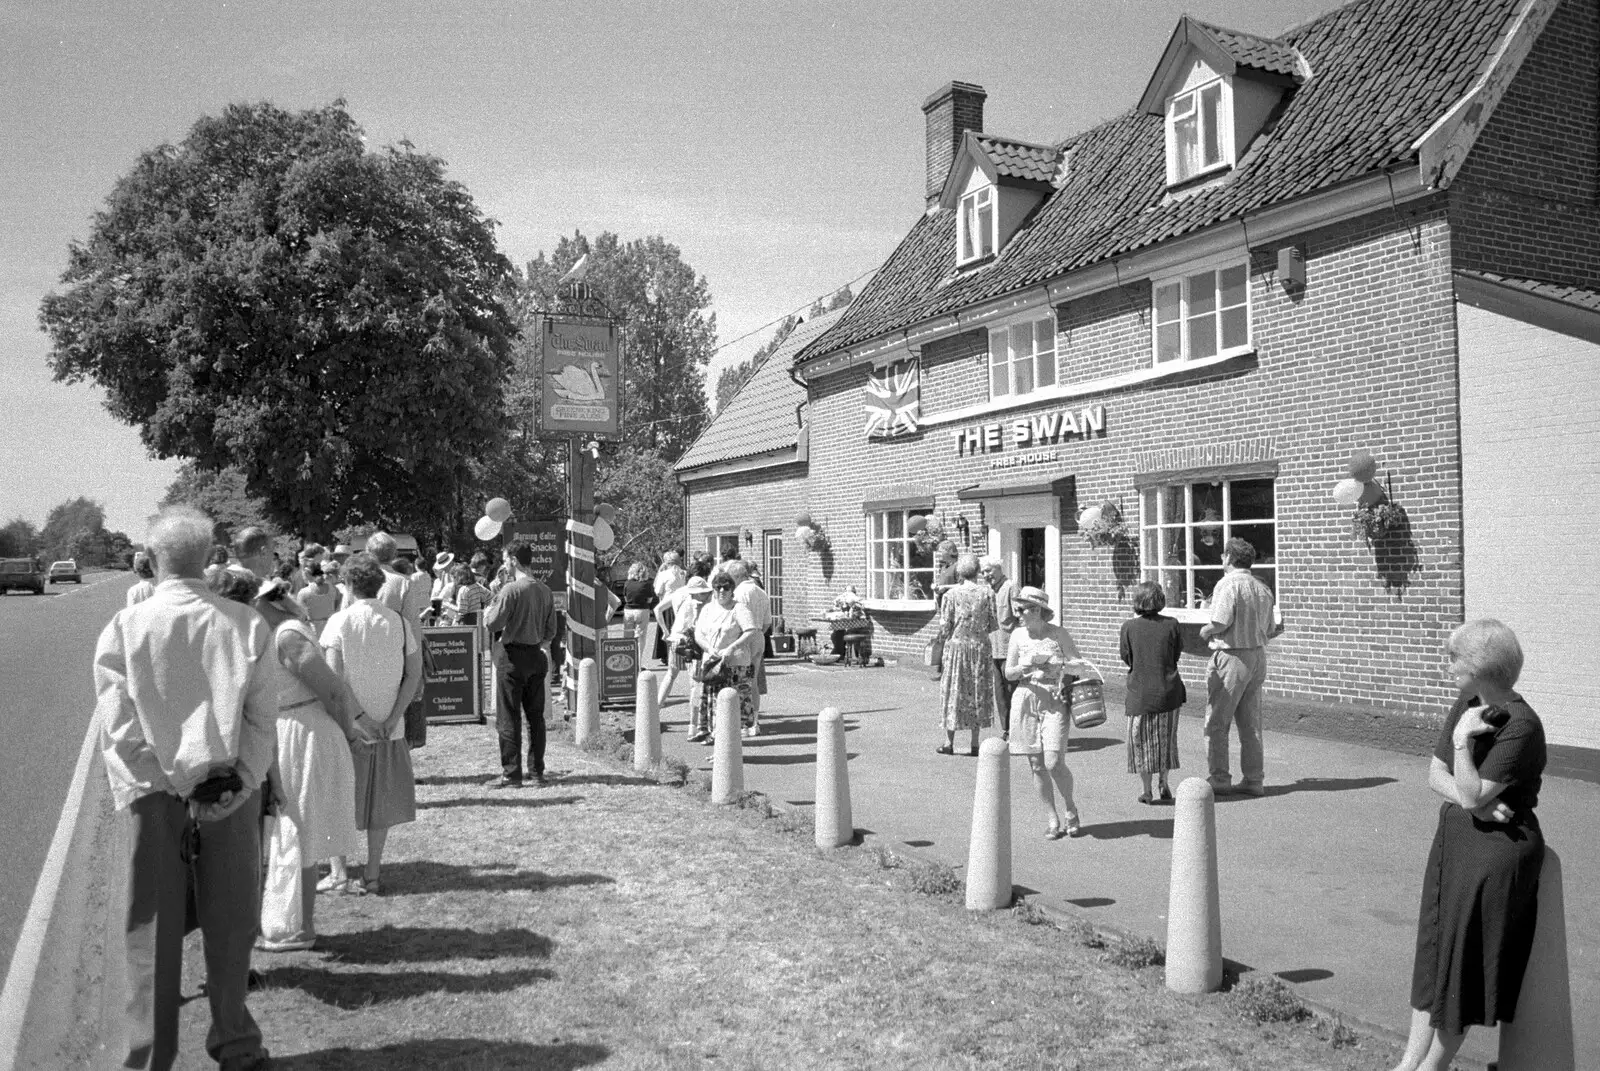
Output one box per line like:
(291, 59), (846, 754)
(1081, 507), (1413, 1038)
(1139, 479), (1278, 610)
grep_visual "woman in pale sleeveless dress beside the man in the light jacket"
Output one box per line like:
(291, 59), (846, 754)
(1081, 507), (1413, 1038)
(253, 581), (378, 953)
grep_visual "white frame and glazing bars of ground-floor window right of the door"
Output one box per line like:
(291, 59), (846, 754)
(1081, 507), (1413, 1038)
(1139, 475), (1283, 621)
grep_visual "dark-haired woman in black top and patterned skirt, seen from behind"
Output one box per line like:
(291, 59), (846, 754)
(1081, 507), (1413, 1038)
(1122, 580), (1189, 804)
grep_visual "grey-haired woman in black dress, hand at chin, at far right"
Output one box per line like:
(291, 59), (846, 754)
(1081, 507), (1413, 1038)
(1395, 618), (1546, 1071)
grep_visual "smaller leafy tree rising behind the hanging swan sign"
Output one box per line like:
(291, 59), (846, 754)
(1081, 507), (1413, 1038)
(520, 231), (717, 461)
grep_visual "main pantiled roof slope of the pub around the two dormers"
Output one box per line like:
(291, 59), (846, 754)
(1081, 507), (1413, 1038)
(803, 0), (1520, 359)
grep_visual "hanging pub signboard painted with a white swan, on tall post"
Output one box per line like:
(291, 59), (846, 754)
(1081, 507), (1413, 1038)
(539, 317), (622, 439)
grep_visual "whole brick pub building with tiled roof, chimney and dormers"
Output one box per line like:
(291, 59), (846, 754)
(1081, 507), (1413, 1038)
(678, 0), (1600, 752)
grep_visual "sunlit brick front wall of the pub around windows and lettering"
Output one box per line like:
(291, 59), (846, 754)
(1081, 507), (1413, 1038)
(793, 199), (1461, 714)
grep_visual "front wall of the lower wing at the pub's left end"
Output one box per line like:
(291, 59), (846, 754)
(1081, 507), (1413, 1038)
(685, 464), (819, 631)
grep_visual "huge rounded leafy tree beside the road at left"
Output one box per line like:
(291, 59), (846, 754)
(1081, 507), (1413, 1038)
(40, 101), (515, 538)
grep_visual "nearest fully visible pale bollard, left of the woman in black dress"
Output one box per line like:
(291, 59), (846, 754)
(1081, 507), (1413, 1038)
(1166, 776), (1222, 993)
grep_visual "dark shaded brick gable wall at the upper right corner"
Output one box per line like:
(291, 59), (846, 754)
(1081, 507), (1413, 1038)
(1450, 0), (1600, 288)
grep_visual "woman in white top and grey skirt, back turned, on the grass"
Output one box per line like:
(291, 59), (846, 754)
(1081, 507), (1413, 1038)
(322, 552), (422, 895)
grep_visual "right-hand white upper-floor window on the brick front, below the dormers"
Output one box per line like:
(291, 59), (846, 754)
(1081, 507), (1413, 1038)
(1150, 248), (1256, 368)
